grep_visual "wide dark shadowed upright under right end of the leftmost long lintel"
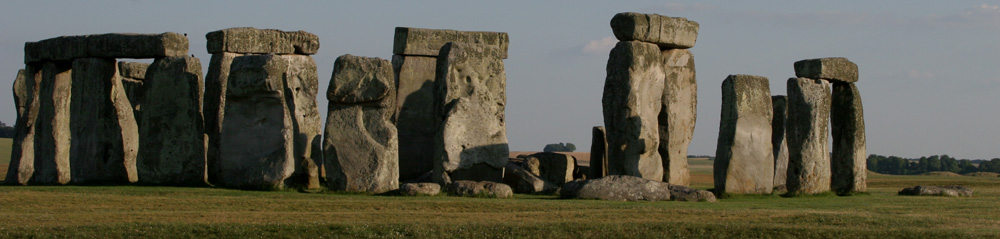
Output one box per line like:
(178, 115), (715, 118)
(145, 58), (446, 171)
(136, 56), (207, 186)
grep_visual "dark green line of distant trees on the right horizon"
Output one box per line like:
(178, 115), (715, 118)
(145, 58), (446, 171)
(868, 154), (1000, 175)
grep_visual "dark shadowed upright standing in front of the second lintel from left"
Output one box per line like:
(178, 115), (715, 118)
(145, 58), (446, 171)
(216, 55), (295, 189)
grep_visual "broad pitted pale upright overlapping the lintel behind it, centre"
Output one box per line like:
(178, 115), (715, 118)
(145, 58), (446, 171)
(433, 43), (510, 184)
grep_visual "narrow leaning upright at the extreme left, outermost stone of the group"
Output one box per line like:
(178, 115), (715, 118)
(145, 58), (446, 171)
(4, 65), (41, 185)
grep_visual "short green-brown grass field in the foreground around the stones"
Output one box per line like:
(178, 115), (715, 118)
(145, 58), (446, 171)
(0, 151), (1000, 238)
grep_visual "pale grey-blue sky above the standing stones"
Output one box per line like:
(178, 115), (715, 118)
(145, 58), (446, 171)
(0, 0), (1000, 159)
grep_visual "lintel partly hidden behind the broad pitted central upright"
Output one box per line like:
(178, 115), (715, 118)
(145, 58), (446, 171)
(392, 27), (510, 59)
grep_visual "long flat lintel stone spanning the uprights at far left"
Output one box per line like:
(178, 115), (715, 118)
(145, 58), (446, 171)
(24, 32), (188, 63)
